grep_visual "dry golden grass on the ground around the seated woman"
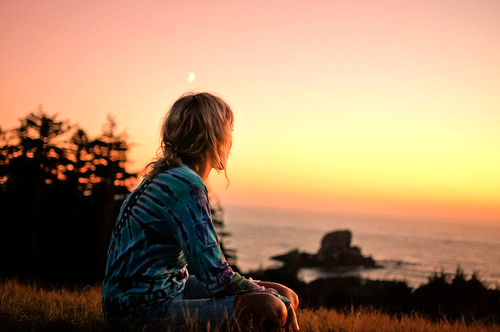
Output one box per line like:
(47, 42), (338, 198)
(0, 280), (500, 332)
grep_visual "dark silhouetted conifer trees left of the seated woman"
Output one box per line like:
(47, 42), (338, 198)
(0, 107), (136, 282)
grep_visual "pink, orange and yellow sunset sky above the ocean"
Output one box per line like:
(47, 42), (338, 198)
(0, 0), (500, 220)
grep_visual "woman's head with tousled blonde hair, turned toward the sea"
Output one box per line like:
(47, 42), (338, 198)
(145, 92), (234, 179)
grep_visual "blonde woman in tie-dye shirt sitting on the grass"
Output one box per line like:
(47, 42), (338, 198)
(102, 93), (299, 331)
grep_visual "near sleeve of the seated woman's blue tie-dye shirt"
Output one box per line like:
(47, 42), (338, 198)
(170, 185), (265, 297)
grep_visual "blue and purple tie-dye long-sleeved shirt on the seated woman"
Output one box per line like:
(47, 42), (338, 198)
(102, 165), (263, 316)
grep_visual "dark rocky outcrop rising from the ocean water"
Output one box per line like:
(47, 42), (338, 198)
(271, 230), (377, 270)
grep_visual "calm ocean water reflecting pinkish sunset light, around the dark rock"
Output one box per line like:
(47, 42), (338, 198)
(223, 205), (500, 288)
